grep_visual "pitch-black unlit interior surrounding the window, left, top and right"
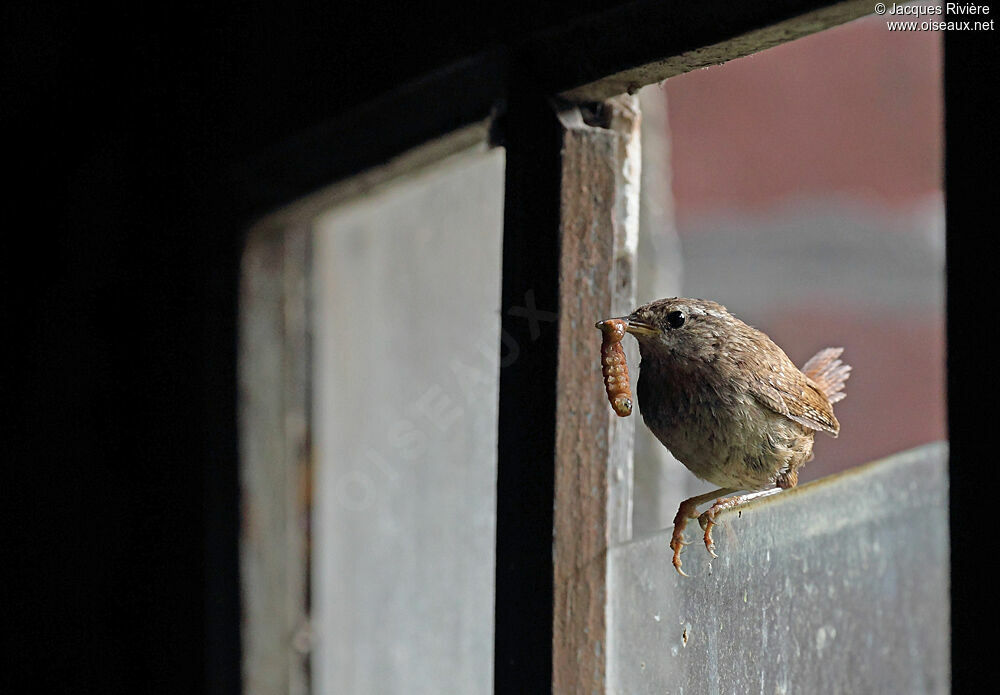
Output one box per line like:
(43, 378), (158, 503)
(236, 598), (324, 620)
(0, 1), (997, 693)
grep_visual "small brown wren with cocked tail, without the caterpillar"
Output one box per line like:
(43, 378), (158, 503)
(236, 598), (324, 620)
(600, 297), (851, 576)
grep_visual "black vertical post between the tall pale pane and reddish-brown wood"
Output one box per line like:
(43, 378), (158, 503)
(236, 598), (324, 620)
(493, 84), (562, 693)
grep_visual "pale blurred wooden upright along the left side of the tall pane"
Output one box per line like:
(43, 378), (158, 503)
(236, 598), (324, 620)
(239, 224), (312, 695)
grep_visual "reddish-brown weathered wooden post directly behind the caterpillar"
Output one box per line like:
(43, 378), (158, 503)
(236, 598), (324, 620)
(552, 96), (640, 694)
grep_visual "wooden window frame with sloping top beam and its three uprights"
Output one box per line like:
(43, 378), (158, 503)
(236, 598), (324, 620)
(239, 0), (920, 693)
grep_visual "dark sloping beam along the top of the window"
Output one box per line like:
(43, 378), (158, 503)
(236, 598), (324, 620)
(229, 0), (874, 215)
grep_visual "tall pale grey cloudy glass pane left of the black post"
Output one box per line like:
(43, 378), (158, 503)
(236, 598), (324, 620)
(312, 150), (504, 694)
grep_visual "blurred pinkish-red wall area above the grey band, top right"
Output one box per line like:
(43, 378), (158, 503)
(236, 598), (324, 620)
(666, 16), (943, 231)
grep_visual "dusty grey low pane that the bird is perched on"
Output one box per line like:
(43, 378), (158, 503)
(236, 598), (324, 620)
(608, 442), (950, 695)
